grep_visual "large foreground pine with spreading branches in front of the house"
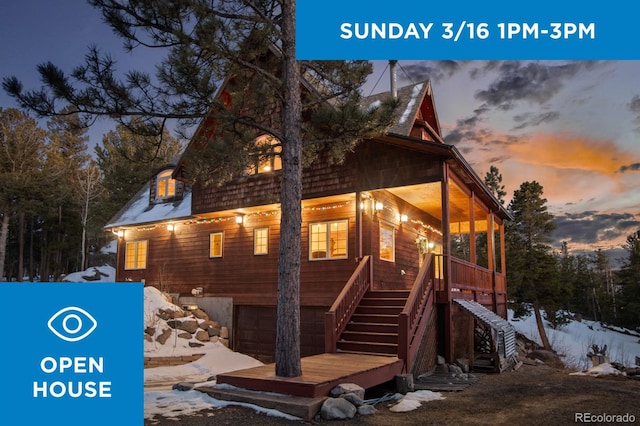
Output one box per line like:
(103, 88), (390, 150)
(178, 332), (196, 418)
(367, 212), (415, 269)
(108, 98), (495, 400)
(3, 0), (397, 377)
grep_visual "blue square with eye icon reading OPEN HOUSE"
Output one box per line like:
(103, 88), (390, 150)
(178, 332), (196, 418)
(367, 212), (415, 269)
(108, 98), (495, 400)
(0, 282), (144, 425)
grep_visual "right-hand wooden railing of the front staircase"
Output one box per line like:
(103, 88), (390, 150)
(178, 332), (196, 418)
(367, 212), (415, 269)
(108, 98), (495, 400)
(398, 253), (435, 371)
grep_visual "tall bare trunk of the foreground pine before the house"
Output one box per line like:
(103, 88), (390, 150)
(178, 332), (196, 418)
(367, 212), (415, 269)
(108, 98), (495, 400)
(276, 0), (302, 377)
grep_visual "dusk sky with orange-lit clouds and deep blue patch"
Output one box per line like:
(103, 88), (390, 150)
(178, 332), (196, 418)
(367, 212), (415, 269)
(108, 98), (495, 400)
(0, 0), (640, 262)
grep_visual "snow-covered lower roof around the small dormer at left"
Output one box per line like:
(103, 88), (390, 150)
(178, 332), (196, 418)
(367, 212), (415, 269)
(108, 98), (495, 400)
(105, 183), (191, 229)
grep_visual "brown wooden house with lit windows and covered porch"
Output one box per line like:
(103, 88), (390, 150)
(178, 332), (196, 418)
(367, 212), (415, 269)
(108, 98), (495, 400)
(106, 82), (511, 372)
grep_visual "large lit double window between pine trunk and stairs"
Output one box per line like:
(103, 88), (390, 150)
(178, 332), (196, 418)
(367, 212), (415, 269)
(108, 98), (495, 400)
(309, 220), (349, 259)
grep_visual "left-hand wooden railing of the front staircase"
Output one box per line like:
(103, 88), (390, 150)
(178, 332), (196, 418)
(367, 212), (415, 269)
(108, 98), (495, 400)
(324, 256), (373, 353)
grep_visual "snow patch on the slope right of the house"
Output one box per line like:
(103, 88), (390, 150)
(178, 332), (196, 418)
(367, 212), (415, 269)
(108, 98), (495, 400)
(509, 310), (640, 370)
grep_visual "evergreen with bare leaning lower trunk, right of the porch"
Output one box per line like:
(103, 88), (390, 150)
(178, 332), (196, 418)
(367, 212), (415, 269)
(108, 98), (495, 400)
(506, 181), (558, 350)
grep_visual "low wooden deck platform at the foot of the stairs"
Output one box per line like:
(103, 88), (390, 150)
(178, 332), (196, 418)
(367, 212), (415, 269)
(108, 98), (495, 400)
(216, 353), (404, 398)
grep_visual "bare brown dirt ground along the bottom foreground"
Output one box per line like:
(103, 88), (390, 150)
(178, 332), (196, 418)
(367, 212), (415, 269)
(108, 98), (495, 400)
(144, 364), (640, 426)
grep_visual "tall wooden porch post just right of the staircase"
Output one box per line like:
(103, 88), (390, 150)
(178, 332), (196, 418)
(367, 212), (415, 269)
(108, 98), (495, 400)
(440, 162), (454, 363)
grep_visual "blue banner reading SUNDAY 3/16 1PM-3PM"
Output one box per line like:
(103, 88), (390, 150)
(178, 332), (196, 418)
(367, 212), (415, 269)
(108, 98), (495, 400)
(296, 0), (640, 60)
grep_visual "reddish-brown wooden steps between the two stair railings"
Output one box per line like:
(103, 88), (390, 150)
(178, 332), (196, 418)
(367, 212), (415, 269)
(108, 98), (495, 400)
(336, 290), (409, 356)
